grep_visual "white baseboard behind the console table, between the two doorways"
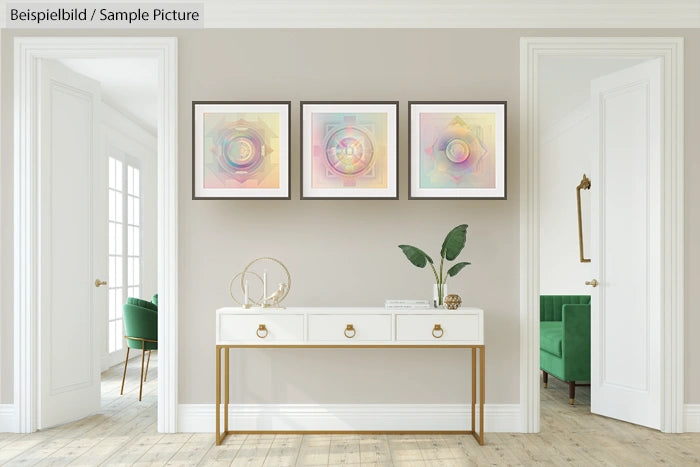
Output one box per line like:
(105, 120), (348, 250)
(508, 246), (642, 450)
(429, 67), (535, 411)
(178, 404), (521, 433)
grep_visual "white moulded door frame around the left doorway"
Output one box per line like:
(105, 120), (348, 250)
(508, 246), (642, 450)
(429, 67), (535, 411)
(13, 37), (178, 433)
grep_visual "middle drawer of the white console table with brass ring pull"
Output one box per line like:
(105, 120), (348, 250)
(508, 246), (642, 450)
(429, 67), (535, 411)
(309, 314), (391, 343)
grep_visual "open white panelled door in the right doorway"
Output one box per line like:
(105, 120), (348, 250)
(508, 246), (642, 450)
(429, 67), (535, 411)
(590, 60), (663, 429)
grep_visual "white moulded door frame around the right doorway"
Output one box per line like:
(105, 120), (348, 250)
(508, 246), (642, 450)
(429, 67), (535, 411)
(520, 37), (684, 433)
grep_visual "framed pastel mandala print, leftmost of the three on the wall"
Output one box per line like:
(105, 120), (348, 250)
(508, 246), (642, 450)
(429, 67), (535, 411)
(192, 101), (291, 199)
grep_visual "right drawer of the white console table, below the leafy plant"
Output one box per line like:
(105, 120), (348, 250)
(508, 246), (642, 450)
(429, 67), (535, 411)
(396, 313), (483, 344)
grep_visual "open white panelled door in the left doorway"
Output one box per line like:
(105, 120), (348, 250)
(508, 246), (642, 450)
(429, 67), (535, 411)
(37, 60), (107, 429)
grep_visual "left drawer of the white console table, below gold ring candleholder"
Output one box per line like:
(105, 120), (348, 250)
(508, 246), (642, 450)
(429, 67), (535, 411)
(217, 314), (304, 344)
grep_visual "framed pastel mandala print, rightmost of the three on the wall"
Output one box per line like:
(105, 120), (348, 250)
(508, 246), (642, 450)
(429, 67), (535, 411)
(408, 102), (506, 199)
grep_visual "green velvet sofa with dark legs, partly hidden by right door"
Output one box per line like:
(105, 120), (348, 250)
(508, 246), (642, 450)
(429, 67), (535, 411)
(540, 295), (591, 404)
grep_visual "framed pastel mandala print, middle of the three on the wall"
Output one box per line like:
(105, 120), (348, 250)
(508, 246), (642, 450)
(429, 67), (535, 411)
(301, 102), (399, 199)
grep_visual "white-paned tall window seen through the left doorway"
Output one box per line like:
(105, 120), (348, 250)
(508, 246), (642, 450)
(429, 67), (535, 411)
(107, 155), (141, 353)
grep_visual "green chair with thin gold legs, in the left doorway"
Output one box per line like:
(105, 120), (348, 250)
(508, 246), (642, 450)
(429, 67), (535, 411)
(120, 297), (158, 400)
